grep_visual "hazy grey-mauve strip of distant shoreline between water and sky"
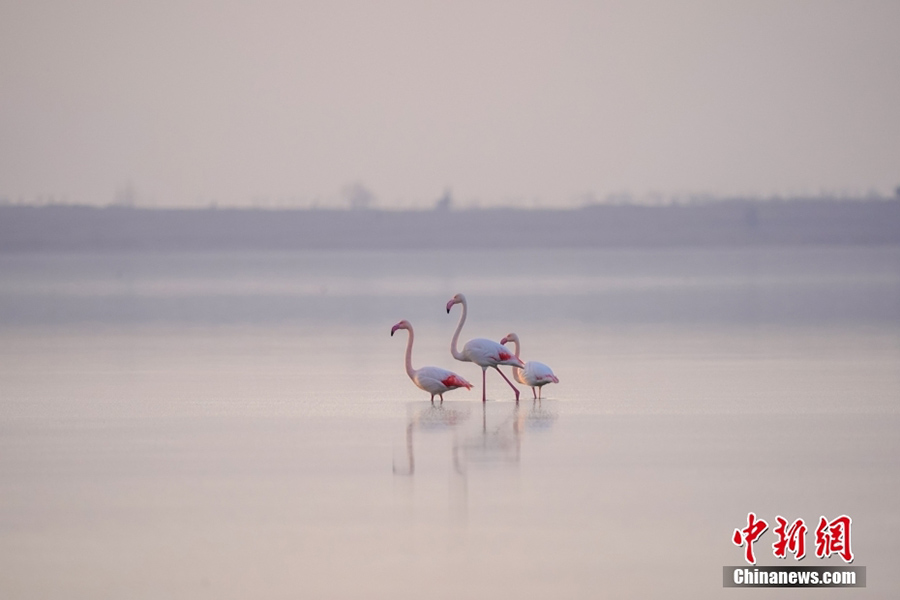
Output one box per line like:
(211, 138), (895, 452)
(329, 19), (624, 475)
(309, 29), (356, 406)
(0, 198), (900, 254)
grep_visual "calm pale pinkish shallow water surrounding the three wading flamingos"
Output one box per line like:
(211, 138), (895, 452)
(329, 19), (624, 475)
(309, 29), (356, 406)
(0, 247), (900, 598)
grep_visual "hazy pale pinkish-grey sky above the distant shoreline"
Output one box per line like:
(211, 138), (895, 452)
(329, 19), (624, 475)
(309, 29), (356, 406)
(0, 0), (900, 206)
